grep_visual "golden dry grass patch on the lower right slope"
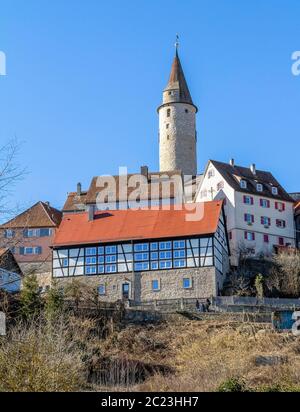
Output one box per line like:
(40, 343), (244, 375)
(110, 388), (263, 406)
(137, 322), (300, 392)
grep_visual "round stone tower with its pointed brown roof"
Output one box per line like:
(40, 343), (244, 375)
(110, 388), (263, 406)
(158, 44), (198, 176)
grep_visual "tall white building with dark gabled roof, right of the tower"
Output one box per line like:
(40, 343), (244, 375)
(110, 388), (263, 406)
(196, 160), (295, 265)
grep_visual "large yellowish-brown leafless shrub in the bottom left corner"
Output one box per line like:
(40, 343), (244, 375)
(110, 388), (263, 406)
(0, 319), (85, 392)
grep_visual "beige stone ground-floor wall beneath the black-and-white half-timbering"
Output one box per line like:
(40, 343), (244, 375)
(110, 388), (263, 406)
(57, 267), (220, 302)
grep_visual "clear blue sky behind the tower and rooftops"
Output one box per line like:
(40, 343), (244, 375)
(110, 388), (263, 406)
(0, 0), (300, 212)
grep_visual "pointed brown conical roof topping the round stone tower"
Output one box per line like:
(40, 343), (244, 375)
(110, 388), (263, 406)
(165, 47), (194, 105)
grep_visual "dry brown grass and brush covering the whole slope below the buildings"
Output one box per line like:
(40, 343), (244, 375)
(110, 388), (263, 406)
(0, 317), (300, 392)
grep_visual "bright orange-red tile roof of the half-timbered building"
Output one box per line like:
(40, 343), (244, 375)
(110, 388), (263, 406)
(53, 201), (222, 247)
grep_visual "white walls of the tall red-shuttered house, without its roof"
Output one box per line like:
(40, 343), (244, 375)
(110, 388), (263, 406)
(196, 162), (295, 265)
